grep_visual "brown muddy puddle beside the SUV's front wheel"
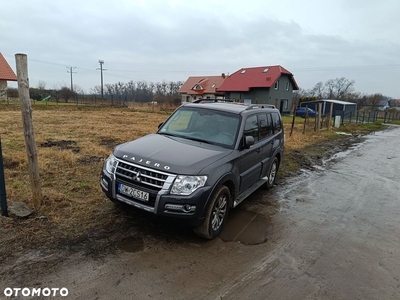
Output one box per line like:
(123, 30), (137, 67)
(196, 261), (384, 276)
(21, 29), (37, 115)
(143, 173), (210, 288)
(220, 209), (272, 245)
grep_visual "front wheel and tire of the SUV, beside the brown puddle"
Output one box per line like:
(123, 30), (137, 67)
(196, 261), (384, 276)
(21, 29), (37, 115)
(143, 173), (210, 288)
(194, 185), (231, 240)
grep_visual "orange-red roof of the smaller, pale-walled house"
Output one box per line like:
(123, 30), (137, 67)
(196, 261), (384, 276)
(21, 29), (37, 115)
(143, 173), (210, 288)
(179, 75), (227, 95)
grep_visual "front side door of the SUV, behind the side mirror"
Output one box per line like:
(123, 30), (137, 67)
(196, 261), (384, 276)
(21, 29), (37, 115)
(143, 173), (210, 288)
(239, 114), (262, 192)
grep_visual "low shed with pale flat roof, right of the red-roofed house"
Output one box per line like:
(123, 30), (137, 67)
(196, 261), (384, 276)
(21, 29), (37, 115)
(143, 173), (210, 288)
(300, 99), (357, 118)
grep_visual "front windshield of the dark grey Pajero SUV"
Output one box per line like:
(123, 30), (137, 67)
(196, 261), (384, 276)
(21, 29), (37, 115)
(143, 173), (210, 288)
(157, 107), (240, 148)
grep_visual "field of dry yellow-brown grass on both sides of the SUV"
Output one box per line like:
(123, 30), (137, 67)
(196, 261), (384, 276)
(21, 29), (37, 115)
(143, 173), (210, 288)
(0, 104), (381, 254)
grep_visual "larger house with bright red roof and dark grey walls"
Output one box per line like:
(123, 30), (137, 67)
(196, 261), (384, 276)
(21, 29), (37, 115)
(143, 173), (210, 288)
(218, 65), (299, 113)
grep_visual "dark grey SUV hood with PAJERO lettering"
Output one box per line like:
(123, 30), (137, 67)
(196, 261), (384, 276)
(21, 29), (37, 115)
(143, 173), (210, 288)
(114, 134), (232, 175)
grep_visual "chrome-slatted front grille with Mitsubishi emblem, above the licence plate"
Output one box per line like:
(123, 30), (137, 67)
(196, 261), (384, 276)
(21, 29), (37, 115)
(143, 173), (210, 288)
(115, 161), (168, 190)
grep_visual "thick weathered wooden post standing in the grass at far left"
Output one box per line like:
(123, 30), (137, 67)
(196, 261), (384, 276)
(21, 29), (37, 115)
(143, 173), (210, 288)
(15, 53), (43, 208)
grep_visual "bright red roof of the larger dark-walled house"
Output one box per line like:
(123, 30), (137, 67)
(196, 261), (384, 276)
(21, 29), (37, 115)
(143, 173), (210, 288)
(218, 66), (299, 92)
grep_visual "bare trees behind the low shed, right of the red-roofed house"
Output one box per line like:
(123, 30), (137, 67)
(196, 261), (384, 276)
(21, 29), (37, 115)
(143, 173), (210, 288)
(293, 77), (391, 110)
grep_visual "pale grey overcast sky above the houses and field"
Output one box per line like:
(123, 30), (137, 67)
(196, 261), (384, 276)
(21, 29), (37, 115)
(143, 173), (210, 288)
(0, 0), (400, 98)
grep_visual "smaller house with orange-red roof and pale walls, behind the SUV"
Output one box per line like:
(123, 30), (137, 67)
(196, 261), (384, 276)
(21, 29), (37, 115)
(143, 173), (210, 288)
(178, 73), (227, 102)
